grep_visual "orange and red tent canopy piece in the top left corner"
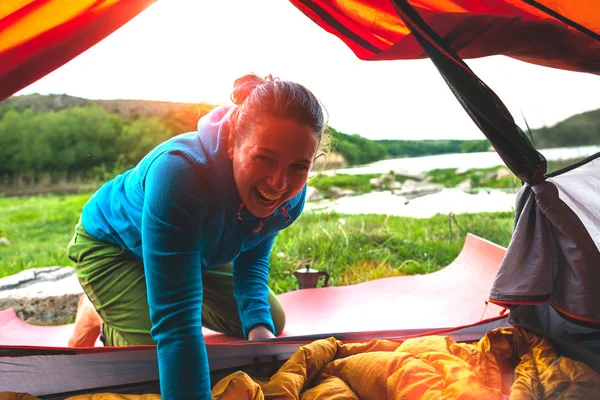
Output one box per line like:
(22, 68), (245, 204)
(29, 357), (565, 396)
(0, 0), (155, 101)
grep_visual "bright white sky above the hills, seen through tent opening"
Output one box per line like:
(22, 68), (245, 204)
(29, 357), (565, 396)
(18, 0), (600, 139)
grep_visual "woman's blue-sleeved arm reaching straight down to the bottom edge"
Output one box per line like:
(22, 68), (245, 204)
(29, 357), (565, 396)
(142, 154), (210, 400)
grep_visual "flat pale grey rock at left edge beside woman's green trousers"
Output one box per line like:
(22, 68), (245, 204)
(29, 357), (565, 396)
(0, 267), (83, 325)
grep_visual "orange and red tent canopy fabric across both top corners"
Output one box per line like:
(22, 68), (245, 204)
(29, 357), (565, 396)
(0, 0), (600, 101)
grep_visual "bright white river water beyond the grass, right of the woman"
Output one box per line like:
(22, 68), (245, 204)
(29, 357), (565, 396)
(306, 146), (600, 218)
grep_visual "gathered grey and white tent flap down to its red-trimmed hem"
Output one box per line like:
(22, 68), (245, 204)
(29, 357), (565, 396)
(490, 154), (600, 327)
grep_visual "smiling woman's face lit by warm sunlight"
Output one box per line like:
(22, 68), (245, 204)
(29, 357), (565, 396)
(229, 119), (319, 218)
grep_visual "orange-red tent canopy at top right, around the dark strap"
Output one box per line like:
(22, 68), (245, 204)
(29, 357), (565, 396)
(291, 0), (600, 74)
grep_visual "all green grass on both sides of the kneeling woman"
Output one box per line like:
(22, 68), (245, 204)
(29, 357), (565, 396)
(0, 194), (514, 293)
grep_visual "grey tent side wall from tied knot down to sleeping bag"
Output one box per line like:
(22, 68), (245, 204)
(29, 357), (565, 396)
(490, 154), (600, 370)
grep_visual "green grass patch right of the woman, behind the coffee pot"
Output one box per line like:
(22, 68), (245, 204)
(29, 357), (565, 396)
(270, 212), (514, 293)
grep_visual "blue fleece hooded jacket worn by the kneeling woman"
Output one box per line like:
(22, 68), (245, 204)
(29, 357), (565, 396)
(82, 106), (306, 400)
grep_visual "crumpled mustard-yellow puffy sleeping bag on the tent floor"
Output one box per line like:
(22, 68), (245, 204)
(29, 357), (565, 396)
(212, 328), (600, 400)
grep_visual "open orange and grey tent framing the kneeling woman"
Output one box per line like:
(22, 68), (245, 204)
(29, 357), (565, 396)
(0, 0), (600, 395)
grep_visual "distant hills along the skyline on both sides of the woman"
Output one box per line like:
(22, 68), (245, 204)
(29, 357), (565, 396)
(0, 94), (600, 169)
